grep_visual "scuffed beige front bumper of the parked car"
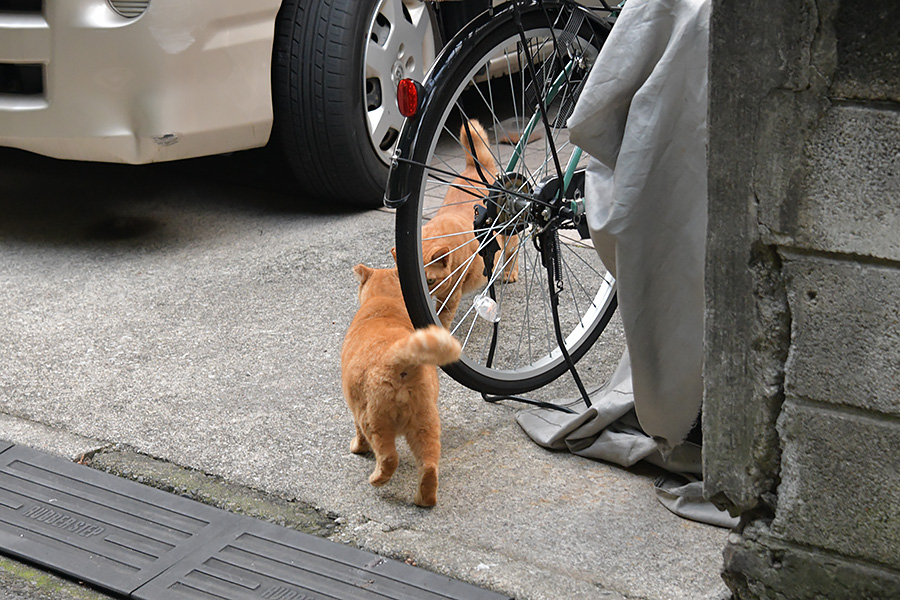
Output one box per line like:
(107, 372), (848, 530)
(0, 0), (281, 163)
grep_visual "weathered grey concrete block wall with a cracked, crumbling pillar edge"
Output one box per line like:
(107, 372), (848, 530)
(703, 0), (900, 600)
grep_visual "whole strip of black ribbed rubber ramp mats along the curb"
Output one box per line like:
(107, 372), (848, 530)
(0, 441), (508, 600)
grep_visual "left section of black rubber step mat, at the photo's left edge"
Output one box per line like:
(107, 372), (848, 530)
(0, 446), (243, 594)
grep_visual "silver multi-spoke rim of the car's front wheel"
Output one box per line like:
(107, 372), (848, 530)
(363, 0), (436, 164)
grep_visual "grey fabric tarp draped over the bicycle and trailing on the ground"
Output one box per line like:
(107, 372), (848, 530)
(517, 0), (735, 526)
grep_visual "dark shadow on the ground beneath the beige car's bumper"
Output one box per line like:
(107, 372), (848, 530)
(0, 147), (370, 247)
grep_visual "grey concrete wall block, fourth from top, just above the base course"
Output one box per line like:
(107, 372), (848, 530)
(772, 400), (900, 569)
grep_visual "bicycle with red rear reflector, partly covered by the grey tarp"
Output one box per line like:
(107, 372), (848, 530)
(385, 0), (616, 410)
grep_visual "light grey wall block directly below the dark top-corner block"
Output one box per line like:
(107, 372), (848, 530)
(760, 105), (900, 260)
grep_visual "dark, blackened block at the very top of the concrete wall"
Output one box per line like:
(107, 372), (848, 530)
(831, 0), (900, 101)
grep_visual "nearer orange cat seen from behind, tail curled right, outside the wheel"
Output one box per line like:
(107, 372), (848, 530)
(341, 265), (460, 506)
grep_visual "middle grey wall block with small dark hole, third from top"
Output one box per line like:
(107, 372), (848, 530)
(783, 254), (900, 414)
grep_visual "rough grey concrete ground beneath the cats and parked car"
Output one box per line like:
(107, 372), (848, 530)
(0, 149), (729, 600)
